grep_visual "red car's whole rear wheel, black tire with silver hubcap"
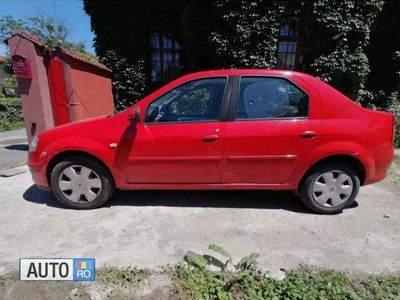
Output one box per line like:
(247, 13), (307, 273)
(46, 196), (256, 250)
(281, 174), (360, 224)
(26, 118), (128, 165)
(299, 163), (360, 214)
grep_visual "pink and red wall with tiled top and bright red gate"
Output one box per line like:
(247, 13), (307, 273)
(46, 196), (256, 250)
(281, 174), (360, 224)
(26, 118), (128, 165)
(6, 31), (114, 142)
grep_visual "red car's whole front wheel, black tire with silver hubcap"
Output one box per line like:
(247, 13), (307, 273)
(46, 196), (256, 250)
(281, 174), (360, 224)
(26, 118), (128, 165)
(50, 156), (115, 209)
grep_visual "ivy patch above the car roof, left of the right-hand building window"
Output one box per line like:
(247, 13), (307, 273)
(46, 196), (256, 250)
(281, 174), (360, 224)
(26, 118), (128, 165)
(210, 1), (285, 68)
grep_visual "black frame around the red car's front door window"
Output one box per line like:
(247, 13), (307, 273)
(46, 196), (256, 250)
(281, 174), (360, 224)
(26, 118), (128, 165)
(143, 75), (233, 125)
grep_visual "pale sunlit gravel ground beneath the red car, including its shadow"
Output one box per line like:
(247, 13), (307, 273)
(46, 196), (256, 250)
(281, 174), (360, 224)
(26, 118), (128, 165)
(0, 172), (400, 274)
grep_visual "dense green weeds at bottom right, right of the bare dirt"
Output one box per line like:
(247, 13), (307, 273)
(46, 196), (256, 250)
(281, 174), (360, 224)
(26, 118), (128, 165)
(168, 246), (400, 300)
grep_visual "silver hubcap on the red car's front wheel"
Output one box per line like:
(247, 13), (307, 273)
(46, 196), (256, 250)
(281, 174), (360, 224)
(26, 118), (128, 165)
(58, 165), (102, 202)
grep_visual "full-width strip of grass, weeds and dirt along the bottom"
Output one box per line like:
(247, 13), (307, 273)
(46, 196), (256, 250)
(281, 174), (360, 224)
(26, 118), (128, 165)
(0, 245), (400, 300)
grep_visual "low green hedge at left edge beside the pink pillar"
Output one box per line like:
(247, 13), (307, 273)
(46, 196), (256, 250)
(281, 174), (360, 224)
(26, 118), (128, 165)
(0, 97), (24, 131)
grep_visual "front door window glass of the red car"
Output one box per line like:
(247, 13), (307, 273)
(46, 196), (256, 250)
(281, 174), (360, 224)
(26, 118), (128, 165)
(146, 77), (226, 123)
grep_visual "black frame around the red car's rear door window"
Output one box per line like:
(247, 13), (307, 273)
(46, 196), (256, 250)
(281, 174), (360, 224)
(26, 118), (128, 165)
(228, 74), (312, 122)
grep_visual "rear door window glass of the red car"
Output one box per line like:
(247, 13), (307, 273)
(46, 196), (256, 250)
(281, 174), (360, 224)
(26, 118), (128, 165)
(236, 77), (308, 119)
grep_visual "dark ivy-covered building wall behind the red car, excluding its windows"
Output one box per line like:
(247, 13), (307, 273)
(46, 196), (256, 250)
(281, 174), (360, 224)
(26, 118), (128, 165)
(84, 0), (400, 108)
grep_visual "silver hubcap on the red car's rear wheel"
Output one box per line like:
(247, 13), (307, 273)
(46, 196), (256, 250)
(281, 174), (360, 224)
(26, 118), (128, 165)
(312, 170), (353, 207)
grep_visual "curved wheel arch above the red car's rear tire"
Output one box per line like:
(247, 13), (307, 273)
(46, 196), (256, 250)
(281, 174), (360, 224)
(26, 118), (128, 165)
(299, 154), (366, 186)
